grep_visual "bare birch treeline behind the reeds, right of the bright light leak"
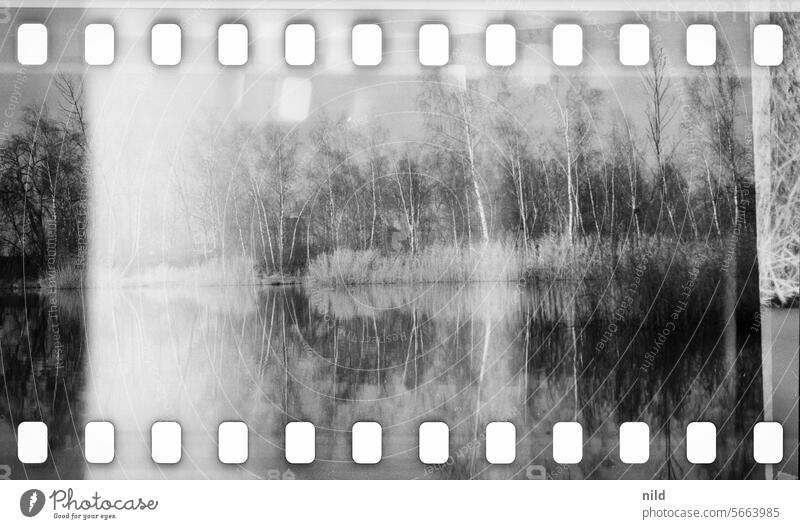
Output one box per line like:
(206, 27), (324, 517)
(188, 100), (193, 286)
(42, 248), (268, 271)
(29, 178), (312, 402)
(174, 46), (755, 272)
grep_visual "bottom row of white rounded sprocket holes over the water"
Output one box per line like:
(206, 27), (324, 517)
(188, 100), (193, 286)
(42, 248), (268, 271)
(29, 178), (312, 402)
(10, 421), (784, 466)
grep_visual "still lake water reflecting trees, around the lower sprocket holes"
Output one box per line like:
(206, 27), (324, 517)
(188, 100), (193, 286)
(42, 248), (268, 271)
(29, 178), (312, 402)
(0, 283), (796, 479)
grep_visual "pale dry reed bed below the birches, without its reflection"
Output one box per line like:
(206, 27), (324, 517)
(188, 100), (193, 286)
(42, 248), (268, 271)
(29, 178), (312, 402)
(308, 236), (708, 286)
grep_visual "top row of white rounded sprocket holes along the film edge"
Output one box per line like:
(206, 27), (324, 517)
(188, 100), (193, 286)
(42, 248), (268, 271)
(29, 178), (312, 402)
(1, 23), (784, 66)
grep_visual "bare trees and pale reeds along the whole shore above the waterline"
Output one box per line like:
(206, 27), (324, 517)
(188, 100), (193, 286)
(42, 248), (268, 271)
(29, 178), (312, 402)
(0, 36), (800, 306)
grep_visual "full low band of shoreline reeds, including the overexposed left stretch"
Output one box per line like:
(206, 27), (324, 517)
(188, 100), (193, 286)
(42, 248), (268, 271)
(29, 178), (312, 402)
(1, 236), (726, 290)
